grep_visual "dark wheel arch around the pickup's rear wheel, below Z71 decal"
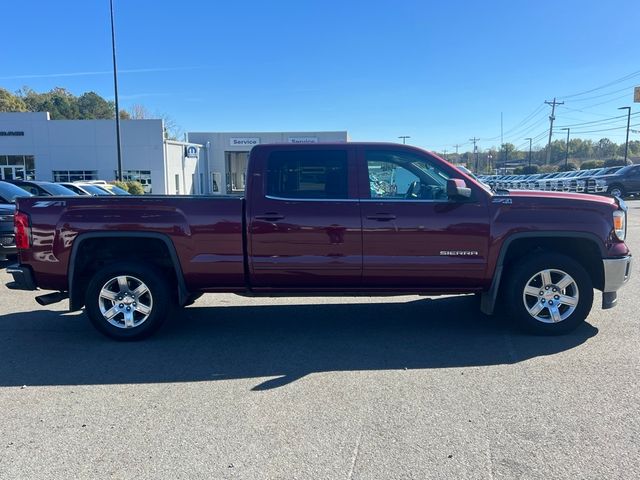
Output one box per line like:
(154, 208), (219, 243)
(67, 232), (189, 311)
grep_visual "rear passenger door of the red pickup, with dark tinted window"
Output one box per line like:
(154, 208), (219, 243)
(248, 145), (362, 290)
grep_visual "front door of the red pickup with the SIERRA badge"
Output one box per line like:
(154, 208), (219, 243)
(358, 146), (490, 290)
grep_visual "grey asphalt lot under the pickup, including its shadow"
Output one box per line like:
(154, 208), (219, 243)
(0, 201), (640, 479)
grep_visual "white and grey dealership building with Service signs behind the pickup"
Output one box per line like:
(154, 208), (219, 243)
(0, 112), (348, 195)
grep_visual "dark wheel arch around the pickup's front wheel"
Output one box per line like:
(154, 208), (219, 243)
(480, 231), (606, 315)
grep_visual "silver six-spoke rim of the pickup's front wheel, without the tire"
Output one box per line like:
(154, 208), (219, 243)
(522, 269), (580, 323)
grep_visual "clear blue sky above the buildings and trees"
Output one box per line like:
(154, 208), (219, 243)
(0, 0), (640, 152)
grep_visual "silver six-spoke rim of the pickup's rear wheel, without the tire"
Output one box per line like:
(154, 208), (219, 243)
(98, 275), (153, 328)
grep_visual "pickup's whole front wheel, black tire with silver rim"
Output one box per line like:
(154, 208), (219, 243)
(503, 253), (593, 335)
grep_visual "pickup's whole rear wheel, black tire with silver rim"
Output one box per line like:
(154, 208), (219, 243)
(85, 262), (174, 340)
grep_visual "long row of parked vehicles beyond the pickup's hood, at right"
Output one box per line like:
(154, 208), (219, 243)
(478, 165), (640, 197)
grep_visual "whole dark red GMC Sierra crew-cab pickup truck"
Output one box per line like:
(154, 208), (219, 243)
(8, 143), (631, 339)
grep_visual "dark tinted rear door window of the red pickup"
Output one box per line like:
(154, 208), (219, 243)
(267, 150), (349, 199)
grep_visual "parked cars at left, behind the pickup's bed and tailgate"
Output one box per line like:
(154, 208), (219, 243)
(0, 180), (129, 259)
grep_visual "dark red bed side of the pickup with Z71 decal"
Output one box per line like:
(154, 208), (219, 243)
(18, 195), (245, 291)
